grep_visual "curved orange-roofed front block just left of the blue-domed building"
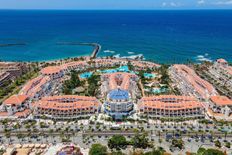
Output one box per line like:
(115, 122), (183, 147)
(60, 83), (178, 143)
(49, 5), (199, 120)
(32, 95), (101, 120)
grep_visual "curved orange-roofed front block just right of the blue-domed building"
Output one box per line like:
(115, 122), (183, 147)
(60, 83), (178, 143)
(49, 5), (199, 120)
(138, 95), (204, 119)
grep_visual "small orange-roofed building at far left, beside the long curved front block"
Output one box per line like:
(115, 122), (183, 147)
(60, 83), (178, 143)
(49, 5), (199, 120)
(0, 95), (30, 117)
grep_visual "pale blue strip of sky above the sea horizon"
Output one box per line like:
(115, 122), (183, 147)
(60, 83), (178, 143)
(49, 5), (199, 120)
(0, 0), (232, 9)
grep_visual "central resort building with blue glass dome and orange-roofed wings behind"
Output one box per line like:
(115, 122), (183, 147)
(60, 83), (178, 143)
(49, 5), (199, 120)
(101, 72), (139, 119)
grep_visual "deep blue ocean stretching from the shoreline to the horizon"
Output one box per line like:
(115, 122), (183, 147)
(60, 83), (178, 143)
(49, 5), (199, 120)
(0, 10), (232, 63)
